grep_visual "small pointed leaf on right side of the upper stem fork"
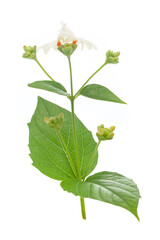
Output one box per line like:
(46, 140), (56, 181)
(80, 84), (125, 104)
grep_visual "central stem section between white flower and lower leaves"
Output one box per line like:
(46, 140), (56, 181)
(68, 57), (81, 180)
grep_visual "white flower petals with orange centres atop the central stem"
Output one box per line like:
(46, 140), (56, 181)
(37, 23), (96, 54)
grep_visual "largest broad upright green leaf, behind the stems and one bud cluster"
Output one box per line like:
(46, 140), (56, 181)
(28, 97), (98, 180)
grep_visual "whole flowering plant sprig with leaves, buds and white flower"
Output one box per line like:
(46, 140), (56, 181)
(23, 24), (140, 220)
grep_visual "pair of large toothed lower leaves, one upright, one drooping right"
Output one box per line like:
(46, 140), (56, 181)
(29, 97), (140, 219)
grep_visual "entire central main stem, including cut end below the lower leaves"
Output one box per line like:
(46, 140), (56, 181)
(68, 57), (86, 219)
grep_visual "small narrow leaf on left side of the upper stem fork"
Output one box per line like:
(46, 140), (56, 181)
(28, 81), (70, 96)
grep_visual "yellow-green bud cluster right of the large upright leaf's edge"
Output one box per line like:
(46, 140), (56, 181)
(96, 124), (115, 141)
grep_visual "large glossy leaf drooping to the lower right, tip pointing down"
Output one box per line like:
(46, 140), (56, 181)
(61, 172), (140, 220)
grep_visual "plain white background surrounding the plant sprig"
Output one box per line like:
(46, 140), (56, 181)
(0, 0), (160, 240)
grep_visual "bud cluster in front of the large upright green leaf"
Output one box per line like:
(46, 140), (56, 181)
(44, 113), (64, 130)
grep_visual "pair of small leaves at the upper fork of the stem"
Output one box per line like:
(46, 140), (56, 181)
(29, 81), (125, 104)
